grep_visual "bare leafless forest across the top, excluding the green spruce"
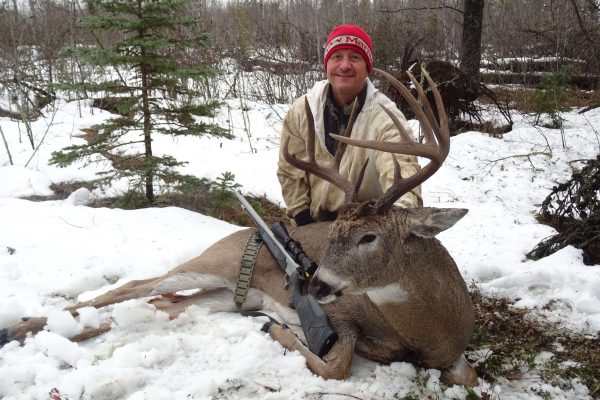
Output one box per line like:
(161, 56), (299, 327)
(0, 0), (600, 112)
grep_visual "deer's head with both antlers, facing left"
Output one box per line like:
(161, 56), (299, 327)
(283, 69), (467, 302)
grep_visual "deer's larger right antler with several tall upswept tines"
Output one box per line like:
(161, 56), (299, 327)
(332, 69), (450, 212)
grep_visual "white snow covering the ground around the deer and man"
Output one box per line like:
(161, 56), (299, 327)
(0, 93), (600, 400)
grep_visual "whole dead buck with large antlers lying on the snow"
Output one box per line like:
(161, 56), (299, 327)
(0, 70), (478, 386)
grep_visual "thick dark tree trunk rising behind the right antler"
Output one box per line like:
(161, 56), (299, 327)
(460, 0), (484, 82)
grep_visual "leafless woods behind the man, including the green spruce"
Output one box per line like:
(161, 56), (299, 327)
(0, 0), (600, 203)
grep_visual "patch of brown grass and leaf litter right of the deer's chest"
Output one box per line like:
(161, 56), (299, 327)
(469, 287), (600, 398)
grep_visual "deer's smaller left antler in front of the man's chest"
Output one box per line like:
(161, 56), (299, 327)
(282, 99), (367, 204)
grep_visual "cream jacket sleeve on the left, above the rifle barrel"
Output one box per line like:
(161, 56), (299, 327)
(277, 97), (310, 218)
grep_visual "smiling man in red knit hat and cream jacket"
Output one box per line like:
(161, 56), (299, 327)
(277, 25), (423, 226)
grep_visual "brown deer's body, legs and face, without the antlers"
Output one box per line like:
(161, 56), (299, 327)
(2, 208), (473, 384)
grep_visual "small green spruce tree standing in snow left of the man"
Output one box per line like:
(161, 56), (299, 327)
(50, 0), (231, 202)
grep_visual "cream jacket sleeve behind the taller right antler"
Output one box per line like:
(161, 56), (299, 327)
(375, 103), (423, 208)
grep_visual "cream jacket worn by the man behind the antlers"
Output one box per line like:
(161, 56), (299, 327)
(277, 79), (423, 221)
